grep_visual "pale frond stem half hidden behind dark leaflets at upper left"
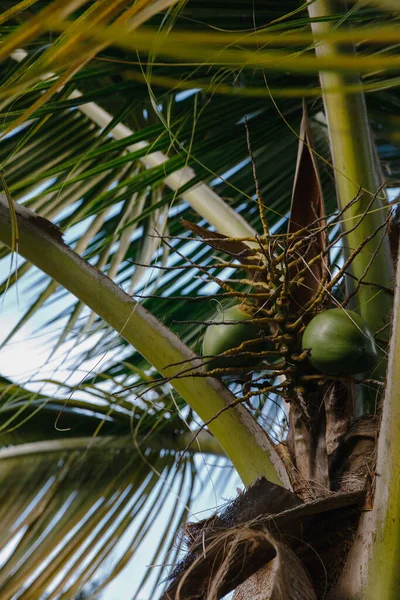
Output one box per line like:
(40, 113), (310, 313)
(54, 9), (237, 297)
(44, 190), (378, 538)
(12, 49), (256, 241)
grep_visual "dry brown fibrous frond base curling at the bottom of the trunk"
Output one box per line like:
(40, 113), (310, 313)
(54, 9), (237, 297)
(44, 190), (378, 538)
(162, 479), (365, 600)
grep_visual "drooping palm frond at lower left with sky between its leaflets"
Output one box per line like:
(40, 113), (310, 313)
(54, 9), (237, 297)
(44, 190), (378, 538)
(0, 379), (232, 598)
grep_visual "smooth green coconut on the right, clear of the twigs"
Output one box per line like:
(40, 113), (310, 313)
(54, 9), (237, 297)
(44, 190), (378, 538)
(302, 308), (378, 375)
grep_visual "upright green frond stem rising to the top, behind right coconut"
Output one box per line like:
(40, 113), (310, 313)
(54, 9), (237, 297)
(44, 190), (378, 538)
(308, 0), (394, 414)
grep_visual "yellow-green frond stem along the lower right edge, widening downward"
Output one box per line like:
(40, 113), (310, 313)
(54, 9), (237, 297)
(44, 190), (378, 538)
(329, 243), (400, 600)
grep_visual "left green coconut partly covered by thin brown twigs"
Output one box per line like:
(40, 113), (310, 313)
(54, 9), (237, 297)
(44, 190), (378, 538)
(203, 304), (271, 371)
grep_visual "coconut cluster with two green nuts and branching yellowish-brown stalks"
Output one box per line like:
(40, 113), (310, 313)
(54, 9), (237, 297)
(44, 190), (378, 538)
(196, 206), (384, 396)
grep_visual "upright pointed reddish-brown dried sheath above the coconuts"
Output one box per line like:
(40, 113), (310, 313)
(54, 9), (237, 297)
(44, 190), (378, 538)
(288, 104), (327, 310)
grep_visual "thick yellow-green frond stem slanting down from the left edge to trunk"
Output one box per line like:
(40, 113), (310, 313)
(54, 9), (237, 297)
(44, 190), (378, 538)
(0, 195), (290, 487)
